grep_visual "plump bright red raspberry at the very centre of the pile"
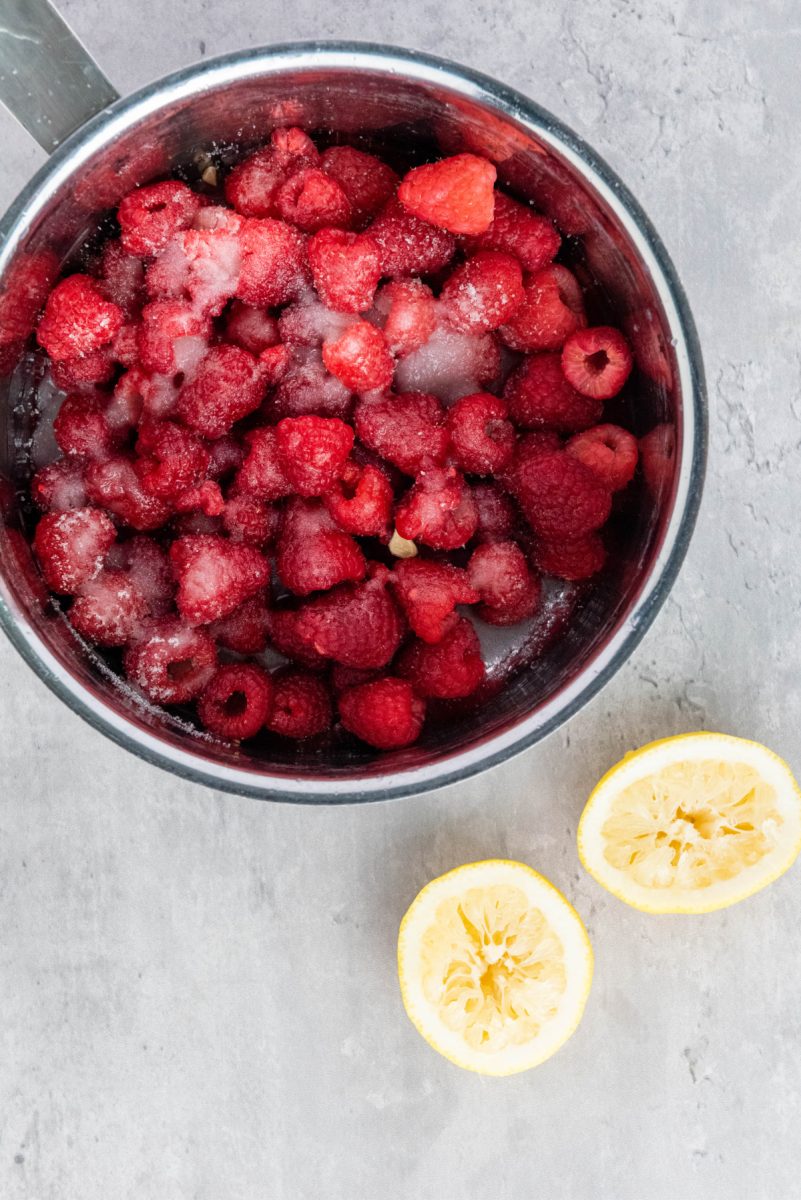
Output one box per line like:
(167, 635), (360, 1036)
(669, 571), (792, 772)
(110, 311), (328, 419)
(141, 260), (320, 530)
(276, 416), (354, 496)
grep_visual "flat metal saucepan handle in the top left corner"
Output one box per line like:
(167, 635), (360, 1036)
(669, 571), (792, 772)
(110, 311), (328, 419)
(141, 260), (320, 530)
(0, 0), (119, 154)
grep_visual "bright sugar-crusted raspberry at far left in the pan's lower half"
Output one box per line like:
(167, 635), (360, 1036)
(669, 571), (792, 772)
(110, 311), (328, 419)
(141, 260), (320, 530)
(34, 509), (116, 595)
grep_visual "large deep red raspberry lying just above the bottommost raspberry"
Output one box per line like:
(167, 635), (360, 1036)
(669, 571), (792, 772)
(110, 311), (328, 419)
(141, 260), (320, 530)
(297, 578), (404, 668)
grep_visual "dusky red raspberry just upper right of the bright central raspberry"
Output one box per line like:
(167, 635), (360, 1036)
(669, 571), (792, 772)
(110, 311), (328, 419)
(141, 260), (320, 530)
(354, 391), (448, 475)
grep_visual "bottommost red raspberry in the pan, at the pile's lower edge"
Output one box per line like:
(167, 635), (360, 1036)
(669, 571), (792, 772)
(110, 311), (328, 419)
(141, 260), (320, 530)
(337, 676), (426, 750)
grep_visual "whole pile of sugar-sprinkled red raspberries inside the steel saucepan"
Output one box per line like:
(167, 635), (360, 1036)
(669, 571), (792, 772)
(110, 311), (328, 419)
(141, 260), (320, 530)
(23, 128), (638, 750)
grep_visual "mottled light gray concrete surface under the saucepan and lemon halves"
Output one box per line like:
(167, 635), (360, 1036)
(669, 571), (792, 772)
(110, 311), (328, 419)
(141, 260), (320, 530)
(0, 0), (801, 1200)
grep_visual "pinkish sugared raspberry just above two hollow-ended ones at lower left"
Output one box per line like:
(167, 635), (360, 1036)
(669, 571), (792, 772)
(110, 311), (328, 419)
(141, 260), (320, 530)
(169, 534), (270, 625)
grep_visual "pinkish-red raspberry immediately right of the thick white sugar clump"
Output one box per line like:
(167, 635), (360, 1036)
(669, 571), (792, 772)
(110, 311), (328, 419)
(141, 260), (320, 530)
(236, 220), (309, 308)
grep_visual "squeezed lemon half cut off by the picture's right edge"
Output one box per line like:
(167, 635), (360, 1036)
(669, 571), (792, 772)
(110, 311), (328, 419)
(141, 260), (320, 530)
(578, 733), (801, 913)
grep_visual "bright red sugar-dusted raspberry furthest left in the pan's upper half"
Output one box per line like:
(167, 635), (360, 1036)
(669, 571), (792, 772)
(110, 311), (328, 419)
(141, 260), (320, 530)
(36, 275), (125, 361)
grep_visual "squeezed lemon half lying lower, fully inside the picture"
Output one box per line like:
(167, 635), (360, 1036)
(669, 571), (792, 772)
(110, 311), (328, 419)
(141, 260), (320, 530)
(398, 859), (592, 1075)
